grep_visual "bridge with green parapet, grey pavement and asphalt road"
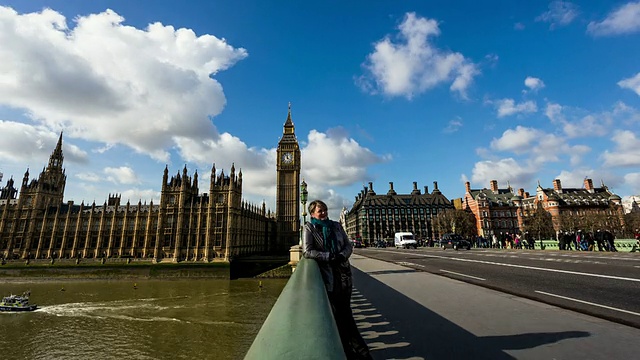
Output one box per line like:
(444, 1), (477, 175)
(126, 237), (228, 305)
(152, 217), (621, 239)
(245, 241), (640, 360)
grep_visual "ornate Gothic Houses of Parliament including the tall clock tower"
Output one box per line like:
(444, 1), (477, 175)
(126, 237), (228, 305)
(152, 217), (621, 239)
(0, 106), (301, 262)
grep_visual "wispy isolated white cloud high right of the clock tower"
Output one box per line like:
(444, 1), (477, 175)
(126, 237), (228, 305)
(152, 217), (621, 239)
(359, 13), (479, 99)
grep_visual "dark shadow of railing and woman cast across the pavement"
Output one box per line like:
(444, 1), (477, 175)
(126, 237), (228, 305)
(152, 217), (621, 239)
(352, 267), (590, 360)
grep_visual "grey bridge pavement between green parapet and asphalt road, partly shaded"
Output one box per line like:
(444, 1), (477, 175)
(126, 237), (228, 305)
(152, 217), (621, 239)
(351, 249), (640, 360)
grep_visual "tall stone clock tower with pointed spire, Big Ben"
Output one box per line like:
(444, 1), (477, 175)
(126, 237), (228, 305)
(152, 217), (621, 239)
(276, 103), (300, 251)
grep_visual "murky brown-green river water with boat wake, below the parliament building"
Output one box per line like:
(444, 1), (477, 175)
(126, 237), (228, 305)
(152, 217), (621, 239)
(0, 279), (287, 360)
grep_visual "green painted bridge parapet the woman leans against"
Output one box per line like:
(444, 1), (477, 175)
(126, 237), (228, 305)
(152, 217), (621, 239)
(245, 258), (345, 360)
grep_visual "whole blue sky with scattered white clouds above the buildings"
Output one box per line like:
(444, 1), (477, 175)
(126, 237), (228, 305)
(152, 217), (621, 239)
(0, 0), (640, 217)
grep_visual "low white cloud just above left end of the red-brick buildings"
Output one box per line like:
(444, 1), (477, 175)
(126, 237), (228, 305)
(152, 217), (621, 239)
(471, 158), (537, 190)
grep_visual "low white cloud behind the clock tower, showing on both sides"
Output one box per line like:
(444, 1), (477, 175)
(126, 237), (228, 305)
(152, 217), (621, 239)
(168, 128), (390, 210)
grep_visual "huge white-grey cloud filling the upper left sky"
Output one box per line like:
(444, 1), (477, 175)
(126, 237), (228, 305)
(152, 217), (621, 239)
(0, 7), (247, 161)
